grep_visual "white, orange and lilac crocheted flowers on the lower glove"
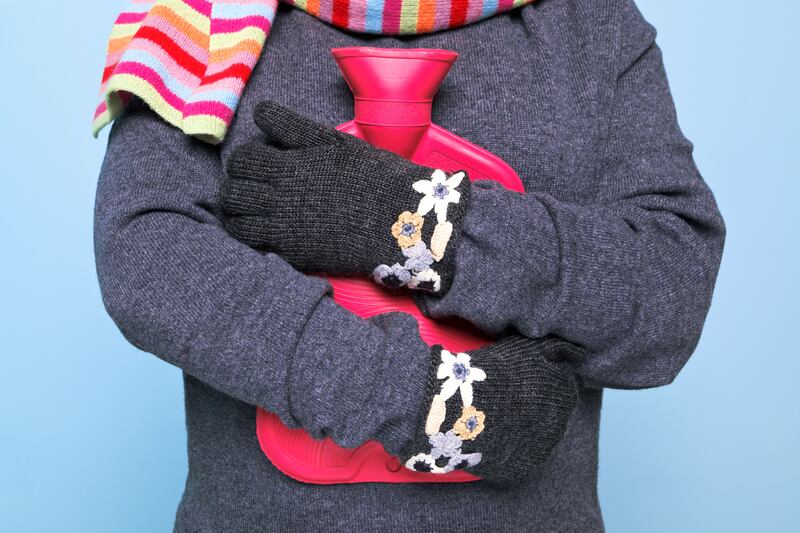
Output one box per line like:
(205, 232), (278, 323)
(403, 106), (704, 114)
(405, 349), (486, 474)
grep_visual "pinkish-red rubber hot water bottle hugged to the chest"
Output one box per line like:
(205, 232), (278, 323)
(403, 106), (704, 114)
(256, 47), (523, 484)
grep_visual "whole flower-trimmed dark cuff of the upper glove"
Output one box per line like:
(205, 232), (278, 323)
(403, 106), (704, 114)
(372, 169), (470, 294)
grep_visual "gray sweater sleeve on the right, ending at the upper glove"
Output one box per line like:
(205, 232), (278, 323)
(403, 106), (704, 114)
(423, 3), (725, 388)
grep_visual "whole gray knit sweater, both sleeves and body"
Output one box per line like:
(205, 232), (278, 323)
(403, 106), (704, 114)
(96, 0), (724, 532)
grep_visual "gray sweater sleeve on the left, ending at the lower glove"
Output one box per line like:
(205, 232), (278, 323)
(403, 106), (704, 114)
(95, 108), (430, 451)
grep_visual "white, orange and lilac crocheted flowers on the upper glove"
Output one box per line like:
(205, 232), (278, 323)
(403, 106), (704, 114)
(372, 169), (466, 293)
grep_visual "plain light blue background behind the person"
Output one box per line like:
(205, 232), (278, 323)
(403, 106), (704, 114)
(0, 0), (800, 533)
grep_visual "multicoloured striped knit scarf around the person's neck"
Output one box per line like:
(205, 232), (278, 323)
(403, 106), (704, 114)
(93, 0), (533, 143)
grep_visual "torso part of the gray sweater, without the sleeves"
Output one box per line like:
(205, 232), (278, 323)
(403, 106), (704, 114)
(176, 2), (620, 532)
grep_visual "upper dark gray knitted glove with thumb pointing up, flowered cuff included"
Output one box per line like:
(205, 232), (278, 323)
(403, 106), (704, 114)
(222, 102), (470, 294)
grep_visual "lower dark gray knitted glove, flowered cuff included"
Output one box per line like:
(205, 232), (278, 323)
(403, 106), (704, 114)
(401, 336), (583, 484)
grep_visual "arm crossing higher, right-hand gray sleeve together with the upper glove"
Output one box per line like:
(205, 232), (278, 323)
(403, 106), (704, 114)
(222, 12), (725, 388)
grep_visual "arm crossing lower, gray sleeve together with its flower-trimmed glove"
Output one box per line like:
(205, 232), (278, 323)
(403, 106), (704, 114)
(95, 101), (581, 483)
